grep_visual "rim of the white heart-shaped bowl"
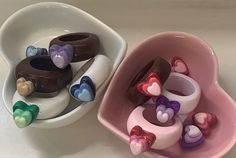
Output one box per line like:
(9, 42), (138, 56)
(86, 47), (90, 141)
(0, 2), (127, 128)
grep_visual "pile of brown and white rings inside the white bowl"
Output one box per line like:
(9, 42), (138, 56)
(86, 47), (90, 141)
(12, 32), (112, 128)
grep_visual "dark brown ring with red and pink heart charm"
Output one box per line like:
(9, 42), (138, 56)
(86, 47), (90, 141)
(127, 57), (171, 105)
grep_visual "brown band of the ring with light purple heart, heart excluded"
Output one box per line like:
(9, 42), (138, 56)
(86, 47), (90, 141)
(49, 32), (100, 62)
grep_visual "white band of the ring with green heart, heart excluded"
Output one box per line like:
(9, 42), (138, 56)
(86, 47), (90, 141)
(12, 88), (70, 119)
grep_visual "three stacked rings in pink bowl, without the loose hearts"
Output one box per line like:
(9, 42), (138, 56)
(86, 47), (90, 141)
(127, 57), (202, 155)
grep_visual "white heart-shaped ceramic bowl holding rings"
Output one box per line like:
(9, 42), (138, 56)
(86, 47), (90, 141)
(0, 2), (127, 128)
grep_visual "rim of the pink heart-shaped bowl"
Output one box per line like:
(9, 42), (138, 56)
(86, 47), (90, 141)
(97, 31), (236, 158)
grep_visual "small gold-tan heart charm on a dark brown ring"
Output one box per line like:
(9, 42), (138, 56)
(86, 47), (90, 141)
(16, 77), (34, 97)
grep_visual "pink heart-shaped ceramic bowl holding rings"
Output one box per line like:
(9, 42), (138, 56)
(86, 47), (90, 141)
(98, 32), (236, 158)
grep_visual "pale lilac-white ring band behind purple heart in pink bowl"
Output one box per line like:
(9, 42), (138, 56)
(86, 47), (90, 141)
(162, 72), (201, 114)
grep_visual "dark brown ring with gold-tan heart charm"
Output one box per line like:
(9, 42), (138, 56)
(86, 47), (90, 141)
(15, 55), (72, 96)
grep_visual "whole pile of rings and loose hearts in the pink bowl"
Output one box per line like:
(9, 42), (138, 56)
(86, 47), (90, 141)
(127, 57), (217, 155)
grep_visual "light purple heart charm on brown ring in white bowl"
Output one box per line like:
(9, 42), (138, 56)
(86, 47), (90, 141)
(49, 44), (73, 68)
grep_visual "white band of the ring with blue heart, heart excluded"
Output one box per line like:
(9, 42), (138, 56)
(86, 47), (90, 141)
(69, 54), (112, 101)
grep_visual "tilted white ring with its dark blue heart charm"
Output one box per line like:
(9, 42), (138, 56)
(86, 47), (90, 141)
(69, 55), (112, 102)
